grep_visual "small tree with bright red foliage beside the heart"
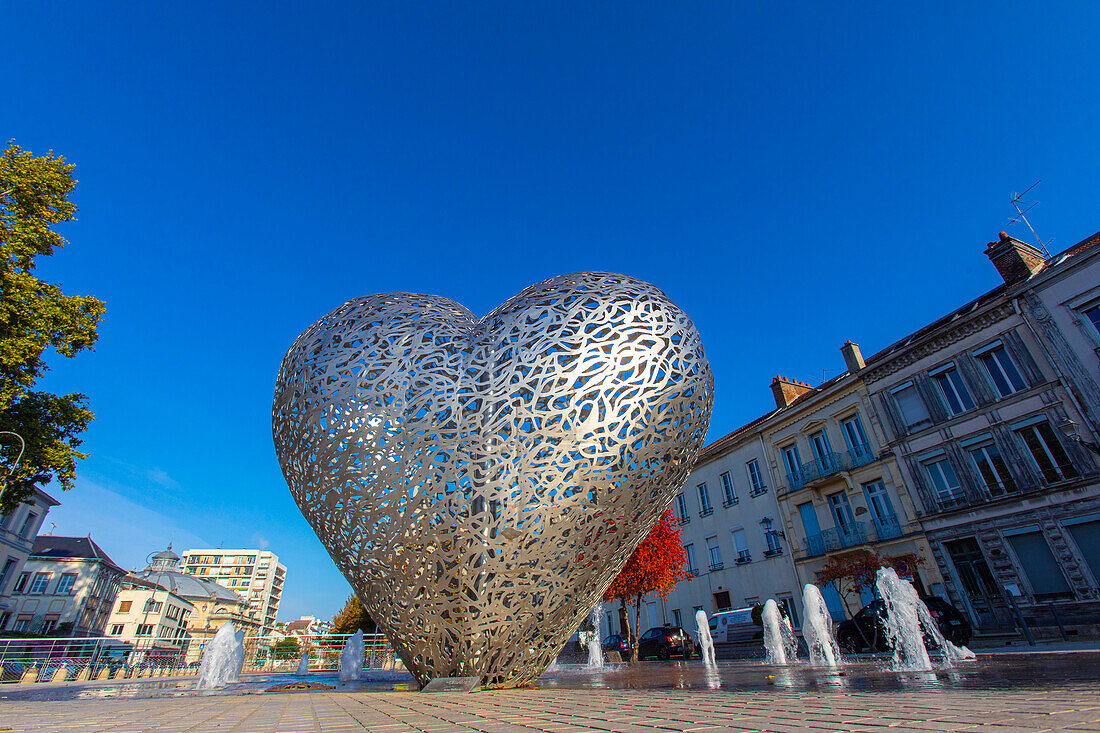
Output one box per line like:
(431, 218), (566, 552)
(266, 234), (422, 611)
(604, 510), (691, 661)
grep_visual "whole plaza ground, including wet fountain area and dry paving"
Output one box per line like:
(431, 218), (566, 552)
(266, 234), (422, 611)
(0, 652), (1100, 733)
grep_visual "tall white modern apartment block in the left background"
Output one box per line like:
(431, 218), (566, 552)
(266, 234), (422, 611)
(183, 549), (286, 636)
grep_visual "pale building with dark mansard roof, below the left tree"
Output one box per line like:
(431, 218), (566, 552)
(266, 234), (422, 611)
(8, 535), (125, 636)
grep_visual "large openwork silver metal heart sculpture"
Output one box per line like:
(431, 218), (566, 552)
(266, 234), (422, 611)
(272, 272), (714, 687)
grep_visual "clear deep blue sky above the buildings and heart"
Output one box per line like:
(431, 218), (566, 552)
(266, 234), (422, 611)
(0, 2), (1100, 619)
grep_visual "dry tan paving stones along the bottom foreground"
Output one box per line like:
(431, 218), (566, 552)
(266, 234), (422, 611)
(0, 683), (1100, 733)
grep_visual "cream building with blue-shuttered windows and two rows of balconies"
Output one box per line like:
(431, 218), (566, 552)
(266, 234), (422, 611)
(761, 354), (943, 621)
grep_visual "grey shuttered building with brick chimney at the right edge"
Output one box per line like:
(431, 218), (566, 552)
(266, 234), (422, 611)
(859, 233), (1100, 630)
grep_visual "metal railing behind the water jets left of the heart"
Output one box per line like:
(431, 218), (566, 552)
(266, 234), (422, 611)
(0, 634), (402, 682)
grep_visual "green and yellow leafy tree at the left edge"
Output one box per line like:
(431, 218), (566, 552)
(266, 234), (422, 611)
(0, 141), (103, 514)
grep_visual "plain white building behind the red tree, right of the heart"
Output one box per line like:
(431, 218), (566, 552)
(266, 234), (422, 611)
(624, 413), (802, 633)
